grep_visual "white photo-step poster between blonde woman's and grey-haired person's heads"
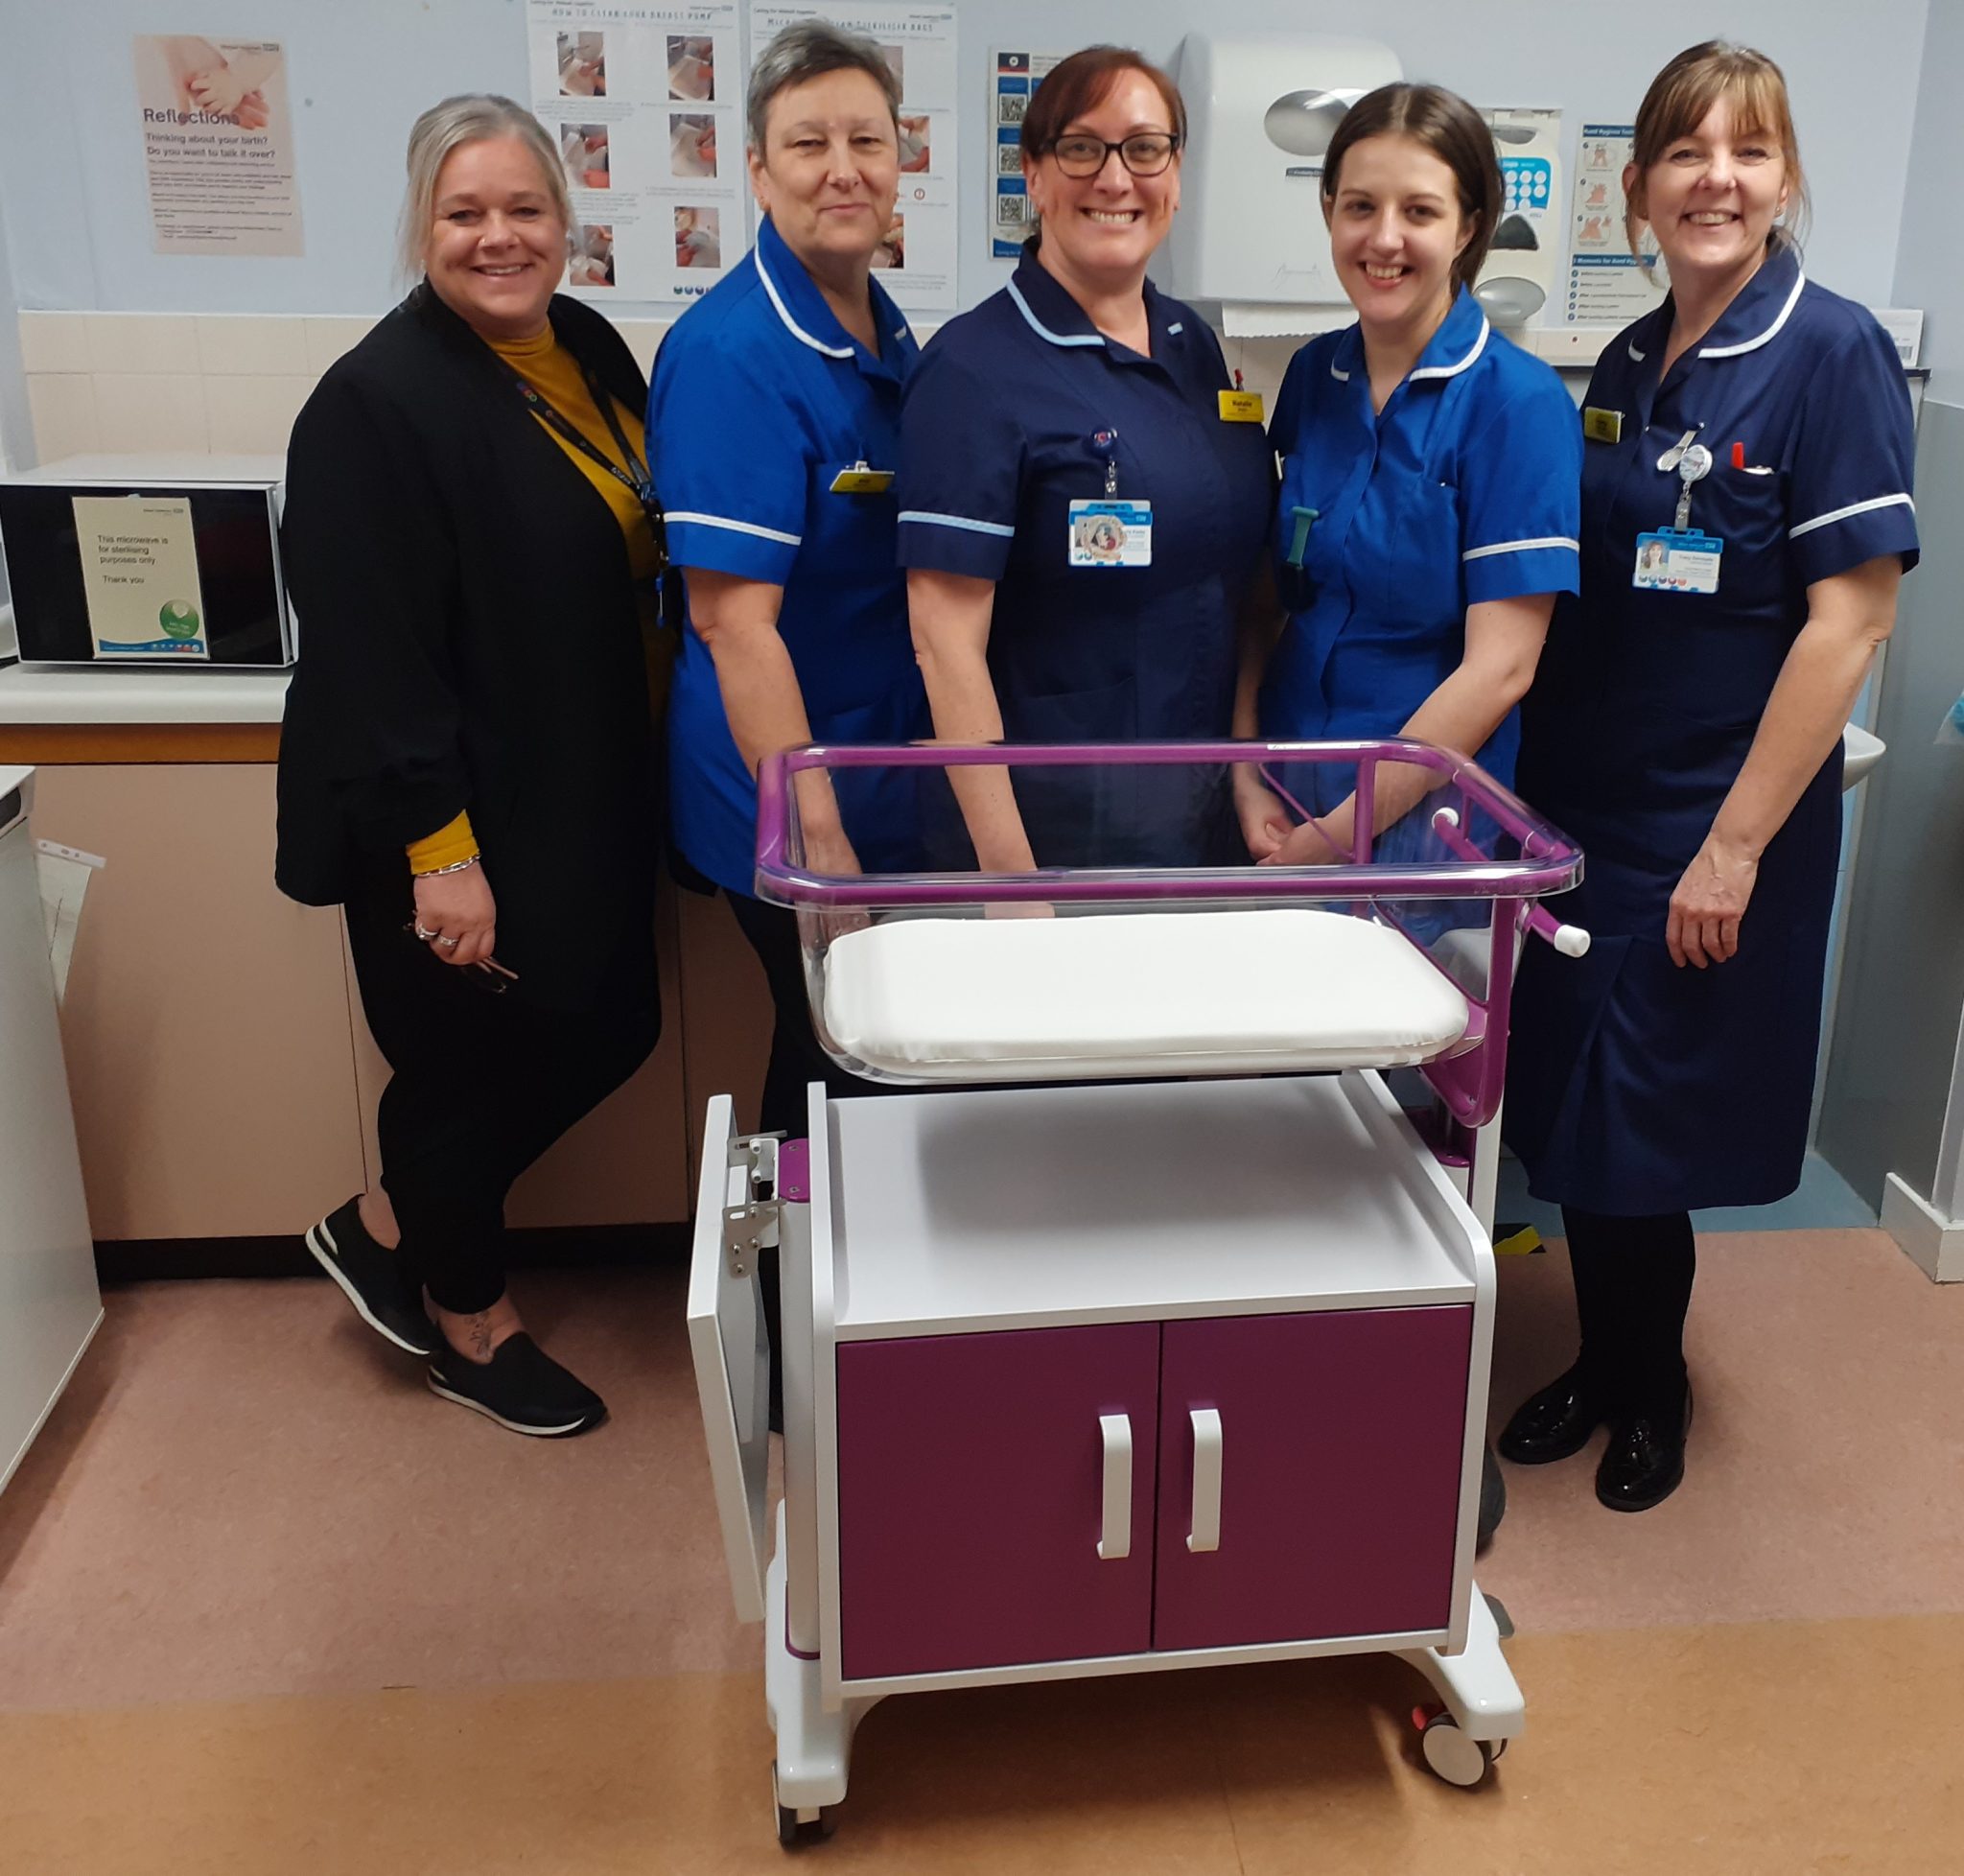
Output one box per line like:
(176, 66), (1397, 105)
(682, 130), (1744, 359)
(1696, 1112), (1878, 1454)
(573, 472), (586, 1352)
(526, 0), (748, 302)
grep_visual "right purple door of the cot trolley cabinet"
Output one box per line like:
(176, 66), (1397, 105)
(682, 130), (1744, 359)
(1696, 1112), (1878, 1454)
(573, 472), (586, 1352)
(1153, 1306), (1473, 1648)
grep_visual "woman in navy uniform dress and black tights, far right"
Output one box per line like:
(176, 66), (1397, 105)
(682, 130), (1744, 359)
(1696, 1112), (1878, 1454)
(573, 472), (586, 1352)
(1501, 43), (1917, 1511)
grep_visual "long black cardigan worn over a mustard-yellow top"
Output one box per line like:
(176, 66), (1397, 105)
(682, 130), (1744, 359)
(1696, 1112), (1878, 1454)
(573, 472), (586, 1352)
(275, 285), (660, 1006)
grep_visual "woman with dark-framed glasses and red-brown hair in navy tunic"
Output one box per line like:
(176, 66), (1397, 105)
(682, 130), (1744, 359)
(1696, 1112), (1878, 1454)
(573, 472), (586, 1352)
(900, 45), (1273, 870)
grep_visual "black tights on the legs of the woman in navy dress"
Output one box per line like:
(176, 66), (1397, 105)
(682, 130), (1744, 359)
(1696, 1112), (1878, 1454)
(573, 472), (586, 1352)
(1561, 1207), (1696, 1413)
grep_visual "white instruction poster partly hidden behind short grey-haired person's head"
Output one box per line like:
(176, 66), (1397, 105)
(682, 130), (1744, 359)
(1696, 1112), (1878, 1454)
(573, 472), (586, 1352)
(750, 0), (956, 313)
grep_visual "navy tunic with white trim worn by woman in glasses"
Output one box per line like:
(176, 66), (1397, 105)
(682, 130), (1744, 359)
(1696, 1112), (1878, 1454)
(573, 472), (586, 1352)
(900, 253), (1274, 864)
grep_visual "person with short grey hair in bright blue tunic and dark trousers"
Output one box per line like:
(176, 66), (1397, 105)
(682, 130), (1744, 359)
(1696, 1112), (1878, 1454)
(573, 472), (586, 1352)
(648, 22), (927, 1136)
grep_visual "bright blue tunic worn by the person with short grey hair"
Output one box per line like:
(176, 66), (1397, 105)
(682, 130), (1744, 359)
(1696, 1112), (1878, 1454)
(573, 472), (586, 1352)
(648, 216), (927, 894)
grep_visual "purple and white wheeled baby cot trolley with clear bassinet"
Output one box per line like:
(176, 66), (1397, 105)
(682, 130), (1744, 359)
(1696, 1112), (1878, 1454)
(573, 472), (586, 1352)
(690, 740), (1585, 1842)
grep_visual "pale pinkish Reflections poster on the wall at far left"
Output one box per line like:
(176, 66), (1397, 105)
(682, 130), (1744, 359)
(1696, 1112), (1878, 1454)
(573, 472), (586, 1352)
(133, 34), (302, 255)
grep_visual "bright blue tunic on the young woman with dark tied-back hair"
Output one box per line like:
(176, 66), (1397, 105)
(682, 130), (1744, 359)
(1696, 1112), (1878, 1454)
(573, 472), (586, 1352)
(1261, 289), (1581, 811)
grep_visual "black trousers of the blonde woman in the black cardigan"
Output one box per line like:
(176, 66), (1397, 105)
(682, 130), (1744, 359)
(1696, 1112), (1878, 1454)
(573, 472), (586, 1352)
(347, 882), (662, 1314)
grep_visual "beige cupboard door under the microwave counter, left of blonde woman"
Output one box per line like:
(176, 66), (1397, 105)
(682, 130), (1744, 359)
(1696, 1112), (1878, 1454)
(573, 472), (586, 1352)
(35, 764), (363, 1239)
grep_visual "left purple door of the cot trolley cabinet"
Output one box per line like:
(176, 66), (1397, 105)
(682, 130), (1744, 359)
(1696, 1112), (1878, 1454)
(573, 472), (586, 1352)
(838, 1322), (1158, 1679)
